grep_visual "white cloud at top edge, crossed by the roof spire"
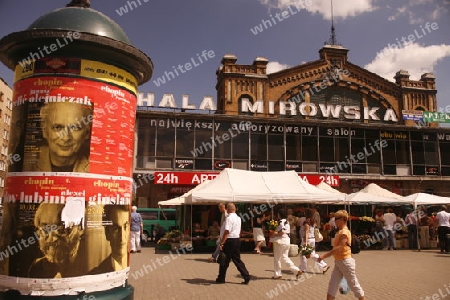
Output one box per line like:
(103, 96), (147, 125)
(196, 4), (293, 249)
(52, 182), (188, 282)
(259, 0), (376, 20)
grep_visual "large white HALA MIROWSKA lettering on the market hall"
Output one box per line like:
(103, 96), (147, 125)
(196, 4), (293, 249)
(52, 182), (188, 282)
(137, 93), (398, 122)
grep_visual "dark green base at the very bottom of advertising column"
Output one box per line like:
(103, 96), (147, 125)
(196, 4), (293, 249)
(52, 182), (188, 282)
(0, 285), (134, 300)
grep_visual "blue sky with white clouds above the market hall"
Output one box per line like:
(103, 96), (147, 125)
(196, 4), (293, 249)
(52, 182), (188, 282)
(0, 0), (450, 112)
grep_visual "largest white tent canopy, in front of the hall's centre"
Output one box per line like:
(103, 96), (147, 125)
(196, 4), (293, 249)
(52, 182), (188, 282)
(186, 169), (344, 204)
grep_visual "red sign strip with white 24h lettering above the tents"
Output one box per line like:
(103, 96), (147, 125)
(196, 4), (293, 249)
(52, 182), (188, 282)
(154, 172), (341, 186)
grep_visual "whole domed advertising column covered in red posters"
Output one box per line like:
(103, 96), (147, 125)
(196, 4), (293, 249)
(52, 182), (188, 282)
(0, 1), (153, 299)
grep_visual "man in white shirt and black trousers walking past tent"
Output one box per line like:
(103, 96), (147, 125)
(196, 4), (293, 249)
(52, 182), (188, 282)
(216, 203), (250, 284)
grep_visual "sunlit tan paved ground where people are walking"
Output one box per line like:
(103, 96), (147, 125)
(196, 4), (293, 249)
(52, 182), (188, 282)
(128, 246), (450, 300)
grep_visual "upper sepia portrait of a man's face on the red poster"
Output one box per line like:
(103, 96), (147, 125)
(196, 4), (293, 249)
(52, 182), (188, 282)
(23, 101), (93, 173)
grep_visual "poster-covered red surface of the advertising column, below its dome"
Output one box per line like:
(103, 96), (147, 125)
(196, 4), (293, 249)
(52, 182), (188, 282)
(0, 59), (136, 295)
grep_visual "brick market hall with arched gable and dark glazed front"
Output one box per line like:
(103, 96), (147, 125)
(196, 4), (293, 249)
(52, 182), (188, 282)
(134, 44), (450, 207)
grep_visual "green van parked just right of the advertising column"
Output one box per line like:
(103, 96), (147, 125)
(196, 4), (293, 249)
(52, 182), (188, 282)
(137, 208), (177, 242)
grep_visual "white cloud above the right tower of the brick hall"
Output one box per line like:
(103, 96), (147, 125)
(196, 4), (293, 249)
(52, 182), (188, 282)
(364, 43), (450, 81)
